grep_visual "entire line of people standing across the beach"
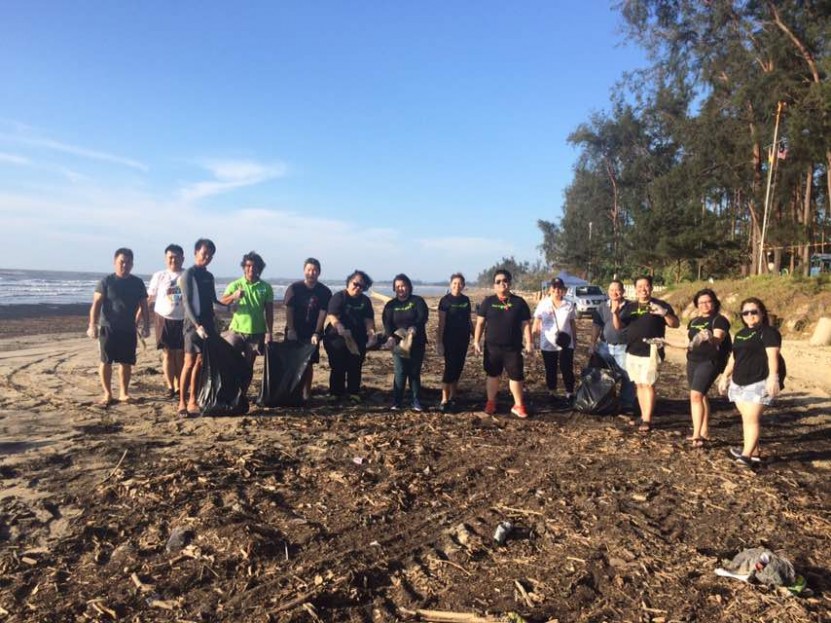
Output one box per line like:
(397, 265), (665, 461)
(88, 244), (783, 466)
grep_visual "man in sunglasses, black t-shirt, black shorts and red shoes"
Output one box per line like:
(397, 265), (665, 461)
(473, 268), (534, 418)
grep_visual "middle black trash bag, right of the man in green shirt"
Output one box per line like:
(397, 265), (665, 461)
(257, 341), (317, 407)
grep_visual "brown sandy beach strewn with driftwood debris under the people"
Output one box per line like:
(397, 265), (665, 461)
(0, 295), (831, 622)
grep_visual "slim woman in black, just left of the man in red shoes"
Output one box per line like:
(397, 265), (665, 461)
(436, 273), (473, 413)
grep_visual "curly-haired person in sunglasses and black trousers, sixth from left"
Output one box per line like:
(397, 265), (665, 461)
(323, 270), (376, 402)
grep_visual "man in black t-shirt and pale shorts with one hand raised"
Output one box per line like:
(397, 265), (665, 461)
(612, 275), (680, 433)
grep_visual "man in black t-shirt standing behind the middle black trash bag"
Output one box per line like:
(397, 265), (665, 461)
(284, 257), (332, 400)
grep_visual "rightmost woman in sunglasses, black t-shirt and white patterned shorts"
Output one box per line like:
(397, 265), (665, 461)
(718, 297), (782, 467)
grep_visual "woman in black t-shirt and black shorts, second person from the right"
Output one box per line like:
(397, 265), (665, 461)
(687, 288), (730, 448)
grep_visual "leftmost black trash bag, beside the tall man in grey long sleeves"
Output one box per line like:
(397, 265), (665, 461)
(197, 335), (251, 416)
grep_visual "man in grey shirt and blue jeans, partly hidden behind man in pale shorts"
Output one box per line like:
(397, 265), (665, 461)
(589, 279), (635, 412)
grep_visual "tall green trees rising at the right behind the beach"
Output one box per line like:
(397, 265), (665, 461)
(538, 0), (831, 283)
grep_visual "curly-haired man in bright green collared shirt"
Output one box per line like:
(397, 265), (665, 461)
(219, 251), (274, 368)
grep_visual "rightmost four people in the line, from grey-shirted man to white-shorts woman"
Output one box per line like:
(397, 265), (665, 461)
(590, 276), (784, 467)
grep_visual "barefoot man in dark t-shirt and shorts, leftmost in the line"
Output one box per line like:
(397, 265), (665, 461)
(87, 248), (150, 407)
